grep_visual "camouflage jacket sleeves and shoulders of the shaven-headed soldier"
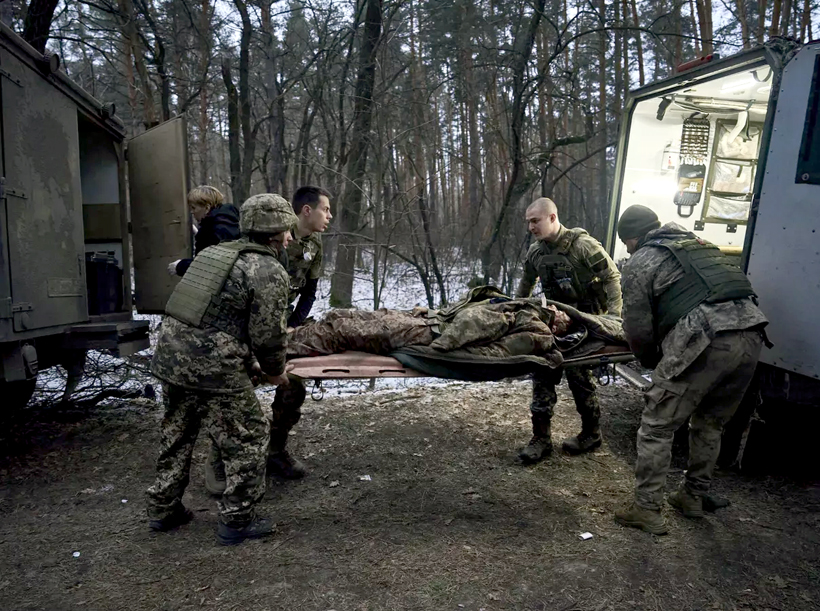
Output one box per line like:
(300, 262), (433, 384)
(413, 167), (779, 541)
(515, 225), (623, 316)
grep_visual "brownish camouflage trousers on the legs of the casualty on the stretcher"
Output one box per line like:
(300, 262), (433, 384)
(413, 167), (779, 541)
(288, 309), (433, 357)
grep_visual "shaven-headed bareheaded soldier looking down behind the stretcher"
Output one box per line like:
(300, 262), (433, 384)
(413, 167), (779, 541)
(515, 197), (622, 463)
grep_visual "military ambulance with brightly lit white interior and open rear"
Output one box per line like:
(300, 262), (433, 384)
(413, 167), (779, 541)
(607, 39), (820, 466)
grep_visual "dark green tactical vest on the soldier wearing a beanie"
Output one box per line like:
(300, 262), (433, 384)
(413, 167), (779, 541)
(645, 237), (755, 340)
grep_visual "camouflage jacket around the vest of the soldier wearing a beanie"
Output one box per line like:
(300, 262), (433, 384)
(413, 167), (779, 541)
(622, 223), (768, 380)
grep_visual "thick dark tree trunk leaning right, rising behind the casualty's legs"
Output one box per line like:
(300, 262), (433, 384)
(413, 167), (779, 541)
(330, 0), (382, 307)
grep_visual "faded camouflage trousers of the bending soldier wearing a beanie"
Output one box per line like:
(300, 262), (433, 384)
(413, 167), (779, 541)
(635, 331), (763, 509)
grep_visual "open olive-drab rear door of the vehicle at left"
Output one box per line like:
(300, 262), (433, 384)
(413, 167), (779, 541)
(127, 117), (193, 314)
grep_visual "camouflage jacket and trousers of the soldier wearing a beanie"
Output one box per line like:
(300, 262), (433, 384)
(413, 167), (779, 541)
(623, 223), (767, 510)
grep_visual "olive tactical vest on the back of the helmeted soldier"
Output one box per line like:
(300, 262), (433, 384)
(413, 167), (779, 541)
(165, 240), (276, 342)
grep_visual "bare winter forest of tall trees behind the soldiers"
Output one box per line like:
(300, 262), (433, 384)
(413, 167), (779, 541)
(0, 0), (820, 307)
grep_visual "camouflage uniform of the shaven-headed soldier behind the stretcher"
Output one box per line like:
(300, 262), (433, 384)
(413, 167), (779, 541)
(515, 226), (623, 454)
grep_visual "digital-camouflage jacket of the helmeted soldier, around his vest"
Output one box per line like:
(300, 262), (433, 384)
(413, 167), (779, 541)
(151, 252), (288, 394)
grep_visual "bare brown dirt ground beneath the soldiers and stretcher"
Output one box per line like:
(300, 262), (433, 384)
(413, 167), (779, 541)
(0, 381), (820, 611)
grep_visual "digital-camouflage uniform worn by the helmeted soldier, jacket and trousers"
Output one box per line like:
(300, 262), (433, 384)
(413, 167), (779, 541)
(148, 232), (288, 526)
